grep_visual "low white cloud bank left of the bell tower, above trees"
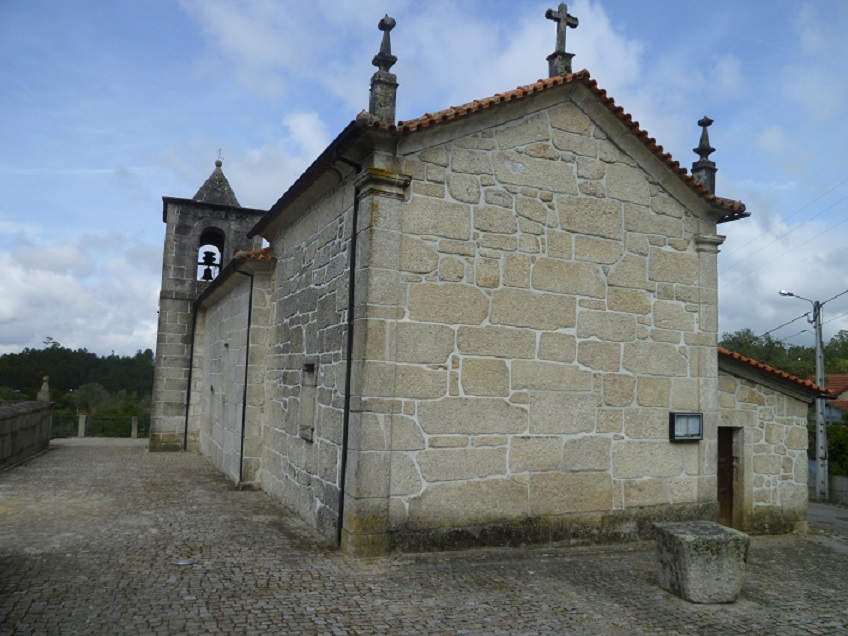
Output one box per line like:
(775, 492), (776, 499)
(0, 232), (161, 354)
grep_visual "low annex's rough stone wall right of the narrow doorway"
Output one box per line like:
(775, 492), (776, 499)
(719, 369), (809, 533)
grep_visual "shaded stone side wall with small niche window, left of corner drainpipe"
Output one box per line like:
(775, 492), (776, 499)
(257, 183), (354, 538)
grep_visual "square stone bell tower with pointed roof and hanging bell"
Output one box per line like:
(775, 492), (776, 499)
(150, 159), (265, 451)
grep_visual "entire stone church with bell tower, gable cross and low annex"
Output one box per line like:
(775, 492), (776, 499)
(150, 4), (823, 555)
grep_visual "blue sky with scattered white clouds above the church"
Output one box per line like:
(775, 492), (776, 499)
(0, 0), (848, 355)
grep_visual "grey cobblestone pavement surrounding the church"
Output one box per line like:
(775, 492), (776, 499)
(0, 440), (848, 635)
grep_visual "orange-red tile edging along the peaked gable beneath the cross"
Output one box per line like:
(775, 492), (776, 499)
(357, 70), (750, 223)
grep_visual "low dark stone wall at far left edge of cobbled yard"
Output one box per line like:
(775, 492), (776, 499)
(0, 402), (53, 469)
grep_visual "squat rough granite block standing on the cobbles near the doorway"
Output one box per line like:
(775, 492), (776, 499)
(654, 521), (750, 603)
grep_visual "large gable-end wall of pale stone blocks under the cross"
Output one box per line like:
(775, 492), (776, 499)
(346, 89), (720, 549)
